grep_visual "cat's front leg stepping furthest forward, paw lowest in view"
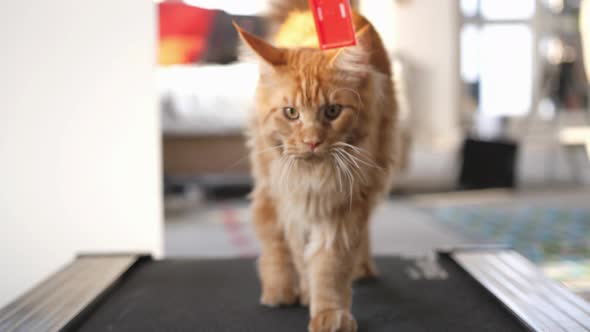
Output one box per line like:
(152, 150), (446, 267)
(307, 227), (358, 332)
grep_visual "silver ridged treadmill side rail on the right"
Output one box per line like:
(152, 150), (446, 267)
(450, 250), (590, 332)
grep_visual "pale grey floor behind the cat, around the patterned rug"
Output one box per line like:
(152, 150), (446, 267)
(165, 189), (590, 296)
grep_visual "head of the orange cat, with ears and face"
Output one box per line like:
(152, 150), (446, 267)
(236, 26), (371, 160)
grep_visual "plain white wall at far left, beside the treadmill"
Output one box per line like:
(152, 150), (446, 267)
(0, 0), (162, 306)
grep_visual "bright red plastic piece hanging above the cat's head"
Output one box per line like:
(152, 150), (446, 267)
(309, 0), (356, 50)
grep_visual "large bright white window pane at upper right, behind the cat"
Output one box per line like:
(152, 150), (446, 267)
(460, 0), (535, 116)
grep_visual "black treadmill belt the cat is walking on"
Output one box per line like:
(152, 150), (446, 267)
(74, 257), (526, 332)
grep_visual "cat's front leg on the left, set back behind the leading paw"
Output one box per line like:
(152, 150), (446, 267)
(252, 191), (298, 307)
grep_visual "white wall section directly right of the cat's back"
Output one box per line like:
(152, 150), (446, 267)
(361, 0), (460, 147)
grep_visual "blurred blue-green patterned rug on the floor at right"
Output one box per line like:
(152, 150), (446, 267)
(432, 204), (590, 296)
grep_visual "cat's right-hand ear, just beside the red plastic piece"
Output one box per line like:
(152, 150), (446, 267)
(330, 24), (372, 78)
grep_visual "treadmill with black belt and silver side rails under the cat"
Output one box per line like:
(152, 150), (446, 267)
(0, 247), (590, 332)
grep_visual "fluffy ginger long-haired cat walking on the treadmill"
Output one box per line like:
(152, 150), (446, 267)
(236, 0), (397, 332)
